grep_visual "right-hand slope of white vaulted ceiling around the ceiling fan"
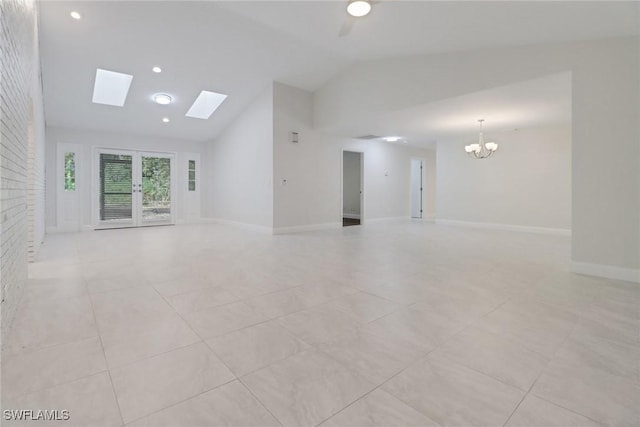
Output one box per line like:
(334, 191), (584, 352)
(220, 0), (638, 60)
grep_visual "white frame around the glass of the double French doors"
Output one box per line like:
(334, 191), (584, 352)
(91, 147), (178, 230)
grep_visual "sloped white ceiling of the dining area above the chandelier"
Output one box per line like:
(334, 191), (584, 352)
(338, 72), (571, 148)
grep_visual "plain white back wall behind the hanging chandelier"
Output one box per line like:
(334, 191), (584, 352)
(437, 124), (571, 230)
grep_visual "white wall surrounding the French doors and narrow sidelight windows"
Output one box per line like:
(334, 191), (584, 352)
(46, 127), (207, 231)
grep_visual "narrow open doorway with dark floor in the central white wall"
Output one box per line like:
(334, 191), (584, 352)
(342, 151), (363, 227)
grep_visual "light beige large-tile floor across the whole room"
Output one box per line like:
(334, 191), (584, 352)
(2, 221), (640, 427)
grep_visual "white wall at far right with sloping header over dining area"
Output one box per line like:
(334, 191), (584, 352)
(314, 37), (640, 278)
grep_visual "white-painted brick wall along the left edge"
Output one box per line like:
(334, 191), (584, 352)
(0, 0), (44, 335)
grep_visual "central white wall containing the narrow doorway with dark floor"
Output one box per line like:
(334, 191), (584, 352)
(274, 83), (435, 232)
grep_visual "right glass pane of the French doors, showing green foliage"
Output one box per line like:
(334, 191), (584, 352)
(142, 156), (171, 221)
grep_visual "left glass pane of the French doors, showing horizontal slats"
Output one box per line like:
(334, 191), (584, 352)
(100, 153), (133, 221)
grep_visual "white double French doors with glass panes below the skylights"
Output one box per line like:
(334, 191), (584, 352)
(94, 149), (175, 228)
